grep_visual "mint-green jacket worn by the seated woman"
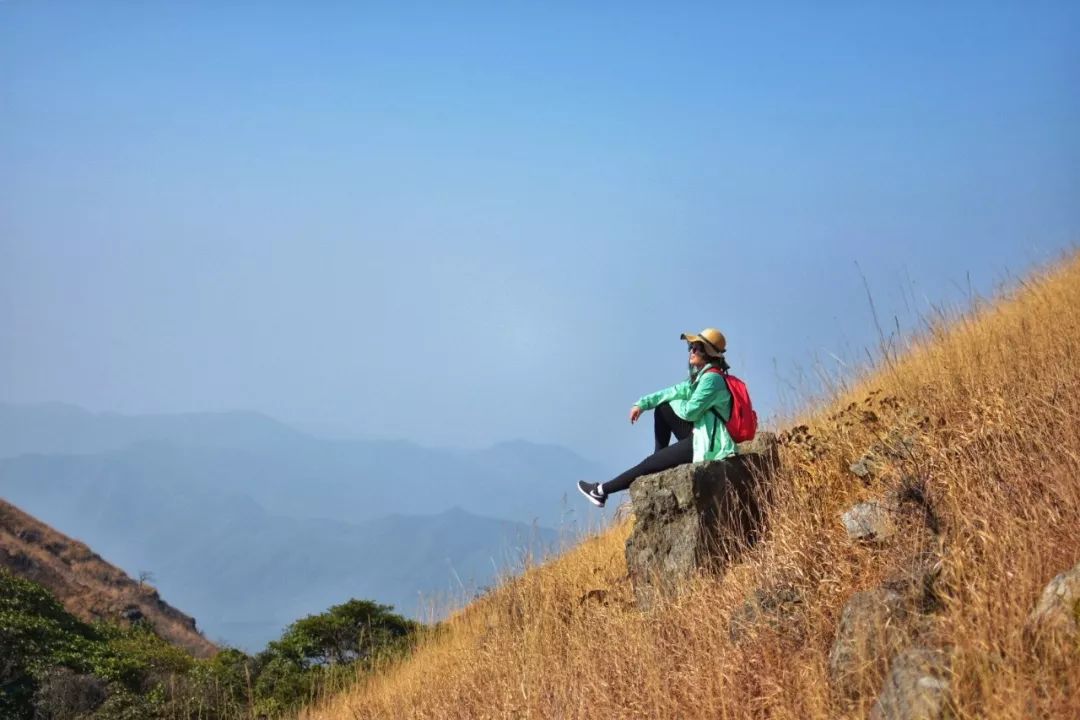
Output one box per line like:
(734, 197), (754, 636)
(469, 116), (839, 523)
(634, 364), (735, 462)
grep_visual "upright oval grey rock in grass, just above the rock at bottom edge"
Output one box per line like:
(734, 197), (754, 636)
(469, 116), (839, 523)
(828, 587), (910, 698)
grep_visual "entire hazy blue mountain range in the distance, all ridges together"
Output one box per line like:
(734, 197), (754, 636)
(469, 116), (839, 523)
(0, 404), (609, 650)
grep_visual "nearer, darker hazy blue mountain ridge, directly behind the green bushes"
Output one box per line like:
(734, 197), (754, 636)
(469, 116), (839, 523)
(0, 457), (556, 650)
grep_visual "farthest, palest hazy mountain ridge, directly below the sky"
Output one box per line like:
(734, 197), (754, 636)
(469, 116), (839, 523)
(0, 404), (611, 527)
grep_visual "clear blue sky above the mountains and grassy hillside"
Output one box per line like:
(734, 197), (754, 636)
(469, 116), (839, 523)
(0, 0), (1080, 464)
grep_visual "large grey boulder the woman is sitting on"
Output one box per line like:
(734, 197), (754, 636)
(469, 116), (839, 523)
(626, 433), (778, 609)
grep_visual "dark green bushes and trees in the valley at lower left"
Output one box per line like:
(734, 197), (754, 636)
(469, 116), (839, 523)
(0, 569), (420, 720)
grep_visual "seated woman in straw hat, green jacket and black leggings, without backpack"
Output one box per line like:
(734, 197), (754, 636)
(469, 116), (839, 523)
(578, 327), (735, 507)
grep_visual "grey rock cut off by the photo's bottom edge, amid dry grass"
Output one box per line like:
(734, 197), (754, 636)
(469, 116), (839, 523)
(869, 648), (951, 720)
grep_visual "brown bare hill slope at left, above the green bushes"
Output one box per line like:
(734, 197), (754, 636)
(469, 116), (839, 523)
(0, 500), (217, 657)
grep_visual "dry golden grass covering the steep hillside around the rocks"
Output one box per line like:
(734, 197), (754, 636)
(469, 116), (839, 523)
(302, 252), (1080, 720)
